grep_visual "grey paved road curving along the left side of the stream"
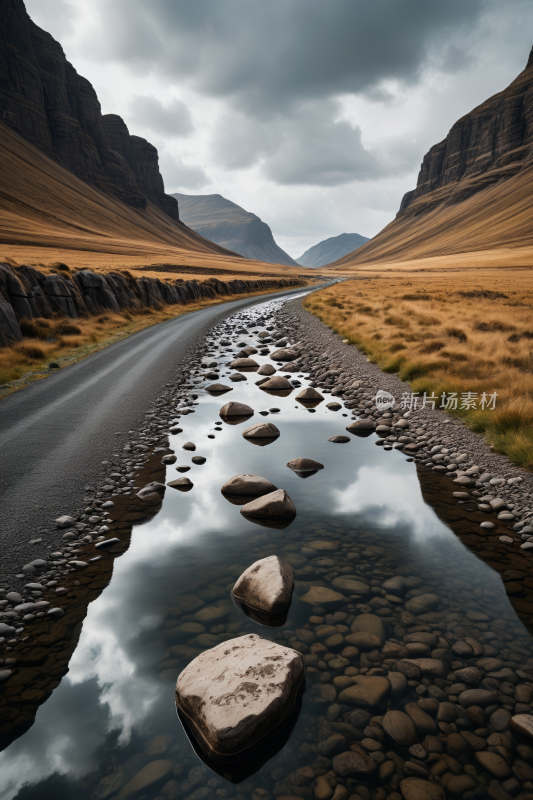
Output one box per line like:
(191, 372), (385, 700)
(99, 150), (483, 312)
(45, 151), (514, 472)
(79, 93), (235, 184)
(0, 287), (326, 586)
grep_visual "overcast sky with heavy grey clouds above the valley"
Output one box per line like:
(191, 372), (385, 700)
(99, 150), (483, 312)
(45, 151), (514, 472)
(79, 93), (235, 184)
(25, 0), (533, 257)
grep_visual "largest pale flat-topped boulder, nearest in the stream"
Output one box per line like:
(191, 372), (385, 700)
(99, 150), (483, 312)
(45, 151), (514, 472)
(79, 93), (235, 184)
(176, 634), (304, 761)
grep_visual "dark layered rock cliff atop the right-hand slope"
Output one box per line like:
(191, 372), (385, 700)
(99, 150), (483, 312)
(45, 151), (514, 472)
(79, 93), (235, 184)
(399, 49), (533, 217)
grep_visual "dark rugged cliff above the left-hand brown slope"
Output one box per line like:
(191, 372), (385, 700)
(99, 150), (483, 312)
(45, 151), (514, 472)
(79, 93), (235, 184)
(0, 0), (178, 220)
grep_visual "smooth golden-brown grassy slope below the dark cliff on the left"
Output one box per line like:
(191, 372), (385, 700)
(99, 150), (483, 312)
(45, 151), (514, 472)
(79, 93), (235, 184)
(0, 123), (306, 275)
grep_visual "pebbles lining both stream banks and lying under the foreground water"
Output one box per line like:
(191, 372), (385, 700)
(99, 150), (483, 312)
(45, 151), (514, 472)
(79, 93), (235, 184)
(0, 300), (533, 800)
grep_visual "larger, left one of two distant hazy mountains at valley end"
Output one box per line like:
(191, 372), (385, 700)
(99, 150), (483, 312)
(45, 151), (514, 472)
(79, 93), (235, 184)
(172, 192), (298, 267)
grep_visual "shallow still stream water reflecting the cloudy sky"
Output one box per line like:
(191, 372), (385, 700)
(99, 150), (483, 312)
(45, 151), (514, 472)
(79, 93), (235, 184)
(0, 298), (533, 800)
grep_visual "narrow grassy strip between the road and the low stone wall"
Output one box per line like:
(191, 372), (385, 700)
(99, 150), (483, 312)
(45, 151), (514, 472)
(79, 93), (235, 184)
(0, 288), (302, 397)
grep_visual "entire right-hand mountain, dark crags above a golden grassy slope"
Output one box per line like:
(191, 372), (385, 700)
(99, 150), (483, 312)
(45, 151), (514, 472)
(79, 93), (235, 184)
(335, 49), (533, 268)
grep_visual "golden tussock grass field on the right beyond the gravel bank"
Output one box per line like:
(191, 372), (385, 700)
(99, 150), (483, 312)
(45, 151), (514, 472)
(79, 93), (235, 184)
(304, 269), (533, 470)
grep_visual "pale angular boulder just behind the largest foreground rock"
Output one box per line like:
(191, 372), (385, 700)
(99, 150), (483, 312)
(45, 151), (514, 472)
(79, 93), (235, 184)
(232, 556), (294, 615)
